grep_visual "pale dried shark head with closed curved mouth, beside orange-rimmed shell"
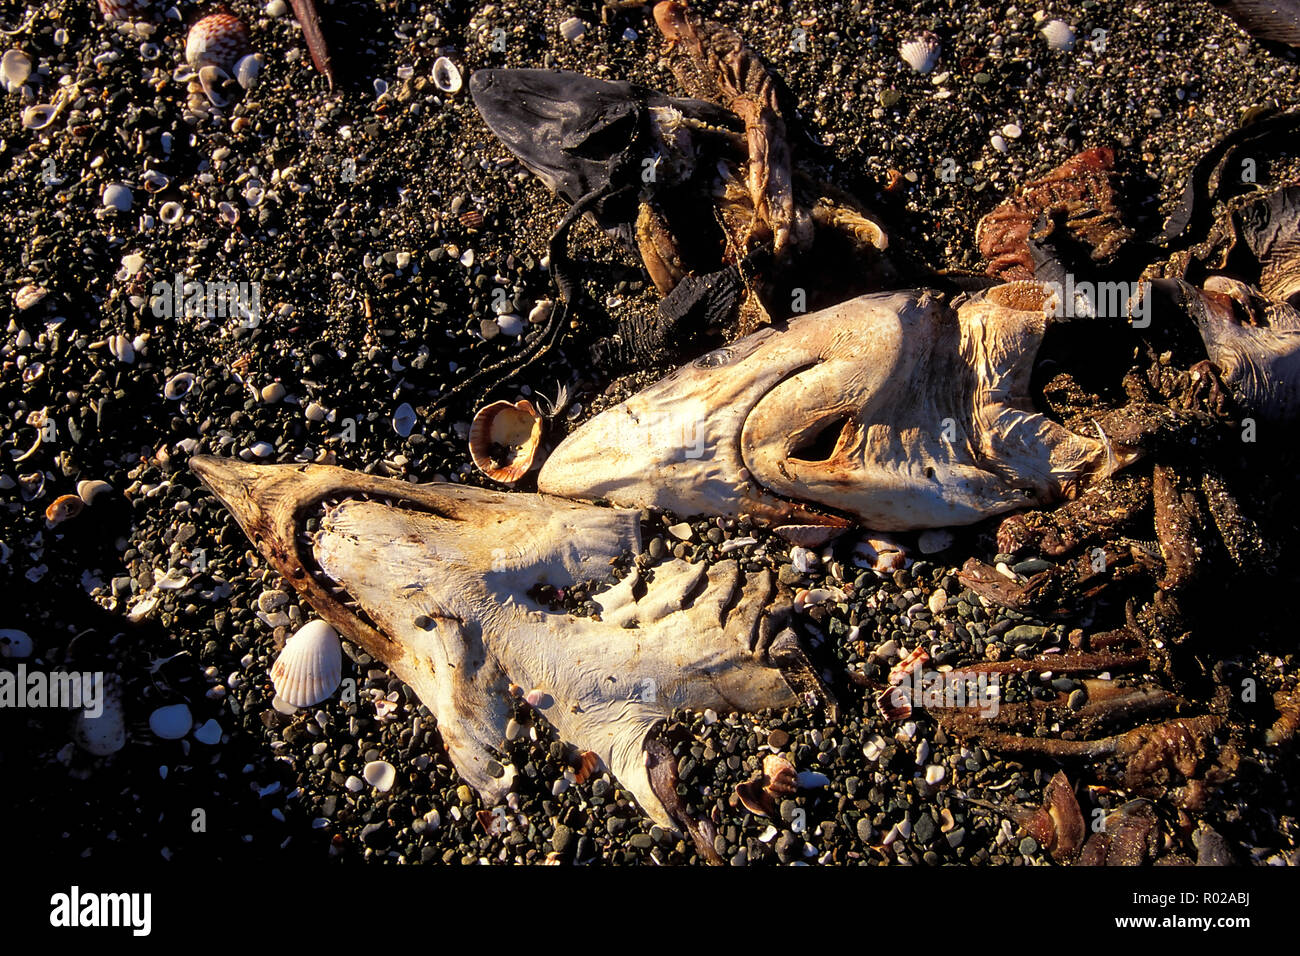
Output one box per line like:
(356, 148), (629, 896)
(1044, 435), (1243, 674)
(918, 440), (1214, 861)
(538, 282), (1135, 540)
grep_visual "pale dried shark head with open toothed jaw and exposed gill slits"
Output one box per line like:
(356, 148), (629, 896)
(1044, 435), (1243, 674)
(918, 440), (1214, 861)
(191, 457), (798, 852)
